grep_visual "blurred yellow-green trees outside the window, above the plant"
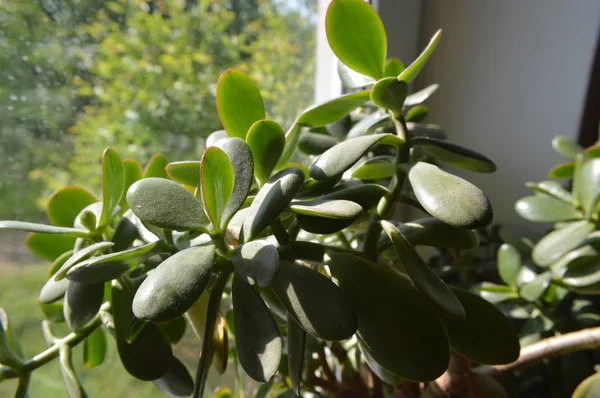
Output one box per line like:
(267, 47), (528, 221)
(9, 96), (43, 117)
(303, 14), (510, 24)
(0, 0), (317, 221)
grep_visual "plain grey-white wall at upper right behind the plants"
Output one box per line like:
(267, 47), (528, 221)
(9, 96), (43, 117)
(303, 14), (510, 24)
(414, 0), (600, 222)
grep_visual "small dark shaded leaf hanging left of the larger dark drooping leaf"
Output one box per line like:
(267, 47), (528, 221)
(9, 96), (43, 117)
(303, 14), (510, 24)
(64, 282), (104, 331)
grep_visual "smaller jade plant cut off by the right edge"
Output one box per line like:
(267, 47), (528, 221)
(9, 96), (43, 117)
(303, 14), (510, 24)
(477, 136), (600, 398)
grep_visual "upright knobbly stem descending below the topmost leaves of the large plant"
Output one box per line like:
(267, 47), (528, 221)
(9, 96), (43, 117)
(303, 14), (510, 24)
(363, 117), (410, 260)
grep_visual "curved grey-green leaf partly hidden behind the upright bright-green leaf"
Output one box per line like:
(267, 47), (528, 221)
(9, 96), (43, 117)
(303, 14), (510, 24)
(213, 138), (254, 230)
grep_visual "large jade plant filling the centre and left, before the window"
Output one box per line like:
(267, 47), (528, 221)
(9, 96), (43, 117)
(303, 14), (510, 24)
(0, 0), (516, 397)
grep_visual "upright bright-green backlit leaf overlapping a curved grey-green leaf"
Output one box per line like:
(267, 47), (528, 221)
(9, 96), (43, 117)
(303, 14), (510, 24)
(200, 146), (237, 231)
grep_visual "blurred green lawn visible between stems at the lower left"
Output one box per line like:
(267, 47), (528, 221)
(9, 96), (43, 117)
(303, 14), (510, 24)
(0, 265), (238, 398)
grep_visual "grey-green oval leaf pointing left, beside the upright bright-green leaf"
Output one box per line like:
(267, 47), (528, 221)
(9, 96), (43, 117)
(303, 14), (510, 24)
(127, 178), (210, 231)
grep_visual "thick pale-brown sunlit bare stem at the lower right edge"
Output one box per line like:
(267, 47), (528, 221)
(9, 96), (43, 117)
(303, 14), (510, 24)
(473, 327), (600, 378)
